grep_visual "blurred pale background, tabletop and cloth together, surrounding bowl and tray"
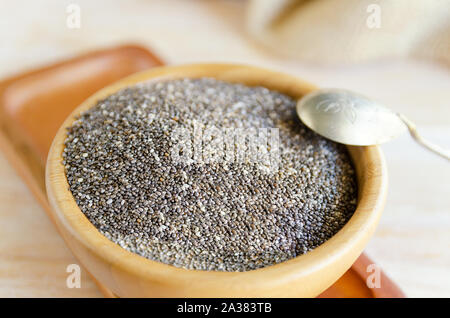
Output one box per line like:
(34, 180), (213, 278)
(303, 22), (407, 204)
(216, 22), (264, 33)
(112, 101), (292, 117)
(0, 0), (450, 297)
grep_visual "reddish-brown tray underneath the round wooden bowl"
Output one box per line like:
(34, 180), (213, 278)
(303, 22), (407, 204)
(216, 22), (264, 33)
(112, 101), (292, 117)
(0, 46), (404, 297)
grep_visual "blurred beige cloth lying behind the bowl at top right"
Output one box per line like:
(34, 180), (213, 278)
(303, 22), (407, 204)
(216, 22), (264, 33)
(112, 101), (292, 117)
(247, 0), (450, 65)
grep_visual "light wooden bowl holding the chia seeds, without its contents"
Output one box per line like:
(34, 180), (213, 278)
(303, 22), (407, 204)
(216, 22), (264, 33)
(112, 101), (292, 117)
(46, 64), (387, 297)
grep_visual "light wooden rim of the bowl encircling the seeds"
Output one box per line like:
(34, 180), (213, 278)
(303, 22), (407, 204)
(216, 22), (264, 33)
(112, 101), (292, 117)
(46, 64), (387, 288)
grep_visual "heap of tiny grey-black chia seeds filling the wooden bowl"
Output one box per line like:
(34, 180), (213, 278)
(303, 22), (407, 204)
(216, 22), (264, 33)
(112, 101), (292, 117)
(63, 78), (357, 271)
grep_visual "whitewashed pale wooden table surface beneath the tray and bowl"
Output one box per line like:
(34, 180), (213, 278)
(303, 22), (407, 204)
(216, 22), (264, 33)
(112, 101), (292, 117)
(0, 0), (450, 297)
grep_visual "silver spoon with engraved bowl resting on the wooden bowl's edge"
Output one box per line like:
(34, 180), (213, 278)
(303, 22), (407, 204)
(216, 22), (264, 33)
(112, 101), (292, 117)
(297, 88), (450, 160)
